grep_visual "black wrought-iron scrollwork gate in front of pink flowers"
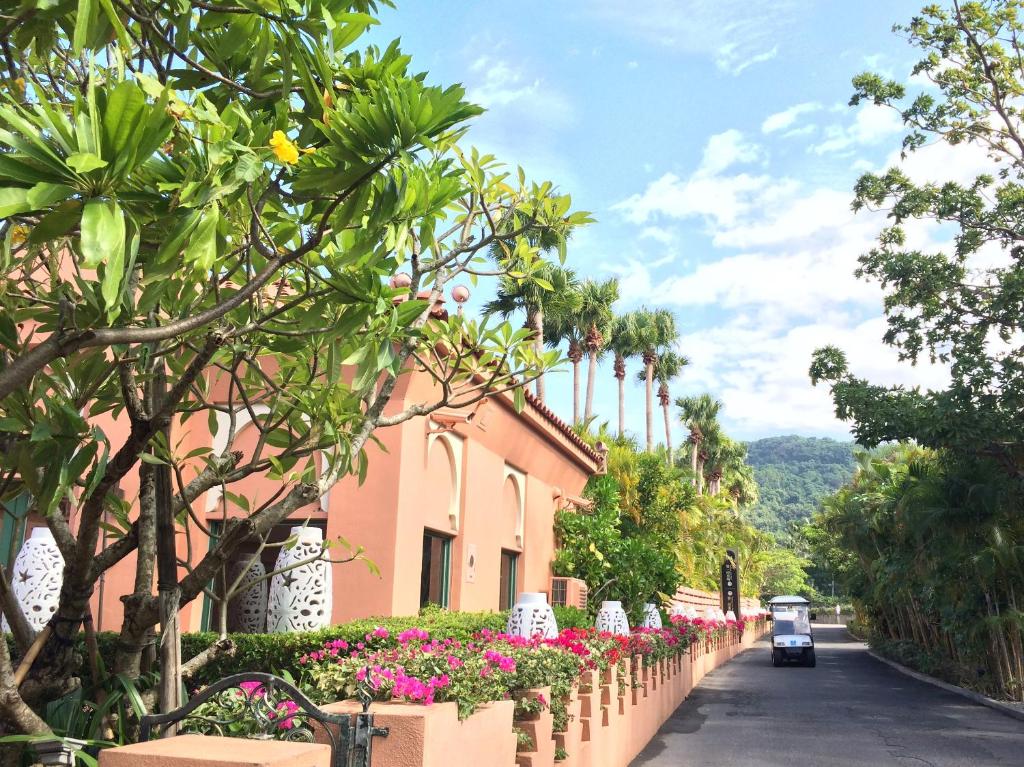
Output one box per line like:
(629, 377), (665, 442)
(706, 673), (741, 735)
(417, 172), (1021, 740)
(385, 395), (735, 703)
(139, 673), (388, 767)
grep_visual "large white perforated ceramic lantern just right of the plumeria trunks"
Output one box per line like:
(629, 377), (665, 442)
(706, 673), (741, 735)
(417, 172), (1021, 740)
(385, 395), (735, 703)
(266, 527), (331, 634)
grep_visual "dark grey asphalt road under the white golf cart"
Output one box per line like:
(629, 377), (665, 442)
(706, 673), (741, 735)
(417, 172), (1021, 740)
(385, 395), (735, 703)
(633, 626), (1024, 767)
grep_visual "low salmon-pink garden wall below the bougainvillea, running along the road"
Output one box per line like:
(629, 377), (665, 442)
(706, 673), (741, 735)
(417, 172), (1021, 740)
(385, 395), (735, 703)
(99, 620), (766, 767)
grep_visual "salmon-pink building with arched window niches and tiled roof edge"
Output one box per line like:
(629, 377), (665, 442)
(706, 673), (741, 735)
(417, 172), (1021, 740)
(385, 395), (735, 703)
(0, 374), (602, 631)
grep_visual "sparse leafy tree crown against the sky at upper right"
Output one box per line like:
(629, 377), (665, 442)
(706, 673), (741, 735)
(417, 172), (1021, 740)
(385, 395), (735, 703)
(810, 0), (1024, 475)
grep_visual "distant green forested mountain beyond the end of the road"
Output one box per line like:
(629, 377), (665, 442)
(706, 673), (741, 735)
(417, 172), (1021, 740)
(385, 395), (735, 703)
(748, 434), (854, 534)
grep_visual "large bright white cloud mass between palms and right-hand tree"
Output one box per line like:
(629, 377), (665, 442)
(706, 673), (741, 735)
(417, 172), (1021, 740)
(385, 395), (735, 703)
(616, 114), (1007, 437)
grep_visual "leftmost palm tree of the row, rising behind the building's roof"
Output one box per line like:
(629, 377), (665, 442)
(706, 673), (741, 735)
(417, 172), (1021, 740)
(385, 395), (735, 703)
(483, 261), (580, 402)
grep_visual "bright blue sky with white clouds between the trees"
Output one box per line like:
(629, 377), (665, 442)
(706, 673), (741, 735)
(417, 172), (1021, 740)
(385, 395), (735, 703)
(372, 0), (966, 445)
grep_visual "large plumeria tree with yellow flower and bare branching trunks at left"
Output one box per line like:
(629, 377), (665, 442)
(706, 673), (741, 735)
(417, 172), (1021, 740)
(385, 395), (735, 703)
(0, 0), (589, 733)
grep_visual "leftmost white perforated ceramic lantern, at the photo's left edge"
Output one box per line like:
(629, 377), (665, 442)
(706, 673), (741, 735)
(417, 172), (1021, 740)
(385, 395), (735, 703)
(3, 527), (63, 632)
